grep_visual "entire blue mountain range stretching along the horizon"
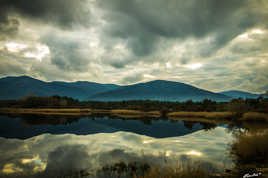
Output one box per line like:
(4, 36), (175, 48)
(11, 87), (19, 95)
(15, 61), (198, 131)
(0, 76), (260, 101)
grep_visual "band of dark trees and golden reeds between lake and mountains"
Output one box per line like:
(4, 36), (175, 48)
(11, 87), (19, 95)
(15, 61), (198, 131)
(0, 96), (268, 122)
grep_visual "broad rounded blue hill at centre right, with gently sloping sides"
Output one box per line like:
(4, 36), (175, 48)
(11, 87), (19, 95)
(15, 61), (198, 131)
(89, 80), (231, 101)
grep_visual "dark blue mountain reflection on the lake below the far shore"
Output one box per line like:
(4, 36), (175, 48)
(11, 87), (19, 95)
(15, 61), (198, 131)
(0, 115), (219, 139)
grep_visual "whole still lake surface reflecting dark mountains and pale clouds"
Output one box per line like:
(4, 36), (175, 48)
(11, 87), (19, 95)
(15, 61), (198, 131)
(0, 115), (251, 177)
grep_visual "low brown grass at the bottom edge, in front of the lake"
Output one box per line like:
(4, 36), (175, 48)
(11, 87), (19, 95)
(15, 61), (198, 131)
(97, 161), (223, 178)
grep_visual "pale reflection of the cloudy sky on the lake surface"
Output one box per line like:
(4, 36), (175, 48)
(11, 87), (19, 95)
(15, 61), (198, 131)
(0, 127), (233, 177)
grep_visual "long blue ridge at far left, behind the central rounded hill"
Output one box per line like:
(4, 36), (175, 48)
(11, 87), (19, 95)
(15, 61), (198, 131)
(0, 76), (119, 100)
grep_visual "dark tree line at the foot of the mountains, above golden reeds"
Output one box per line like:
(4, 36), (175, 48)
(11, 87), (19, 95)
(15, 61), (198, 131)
(0, 95), (268, 113)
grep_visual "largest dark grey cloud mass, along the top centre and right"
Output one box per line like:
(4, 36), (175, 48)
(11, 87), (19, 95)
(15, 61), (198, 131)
(98, 0), (258, 56)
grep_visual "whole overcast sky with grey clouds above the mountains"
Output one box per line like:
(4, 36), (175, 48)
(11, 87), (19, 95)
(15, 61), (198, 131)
(0, 0), (268, 92)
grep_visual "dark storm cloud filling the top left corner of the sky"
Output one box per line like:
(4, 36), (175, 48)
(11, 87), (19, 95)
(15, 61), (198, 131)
(0, 0), (90, 28)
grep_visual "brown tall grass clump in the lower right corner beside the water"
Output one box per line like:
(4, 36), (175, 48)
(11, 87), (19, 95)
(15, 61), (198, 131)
(230, 129), (268, 178)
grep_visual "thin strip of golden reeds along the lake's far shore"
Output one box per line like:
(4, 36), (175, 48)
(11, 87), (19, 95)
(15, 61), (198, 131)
(0, 108), (268, 124)
